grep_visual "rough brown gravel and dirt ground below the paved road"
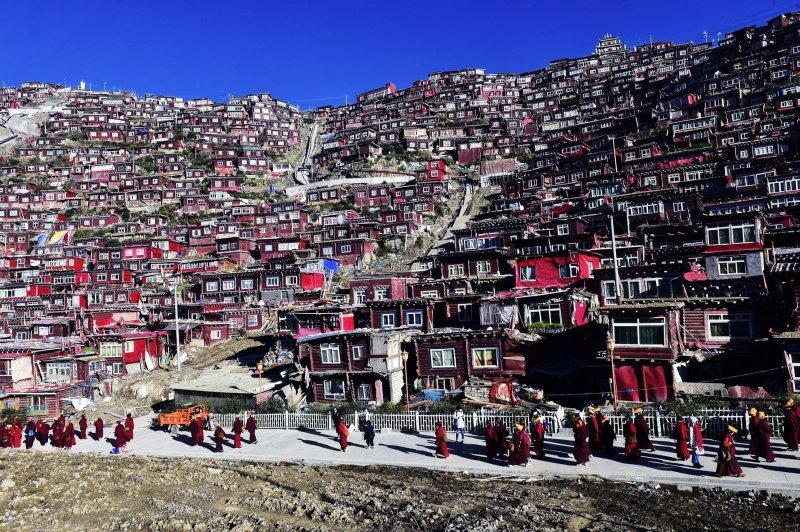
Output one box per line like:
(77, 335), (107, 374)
(0, 451), (800, 531)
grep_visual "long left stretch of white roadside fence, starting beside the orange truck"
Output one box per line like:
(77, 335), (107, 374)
(214, 411), (561, 434)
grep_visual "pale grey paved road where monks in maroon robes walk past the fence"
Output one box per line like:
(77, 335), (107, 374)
(20, 418), (800, 496)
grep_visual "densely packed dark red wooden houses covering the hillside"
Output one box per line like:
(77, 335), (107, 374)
(0, 10), (800, 414)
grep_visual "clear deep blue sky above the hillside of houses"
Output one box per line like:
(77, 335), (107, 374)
(0, 0), (800, 108)
